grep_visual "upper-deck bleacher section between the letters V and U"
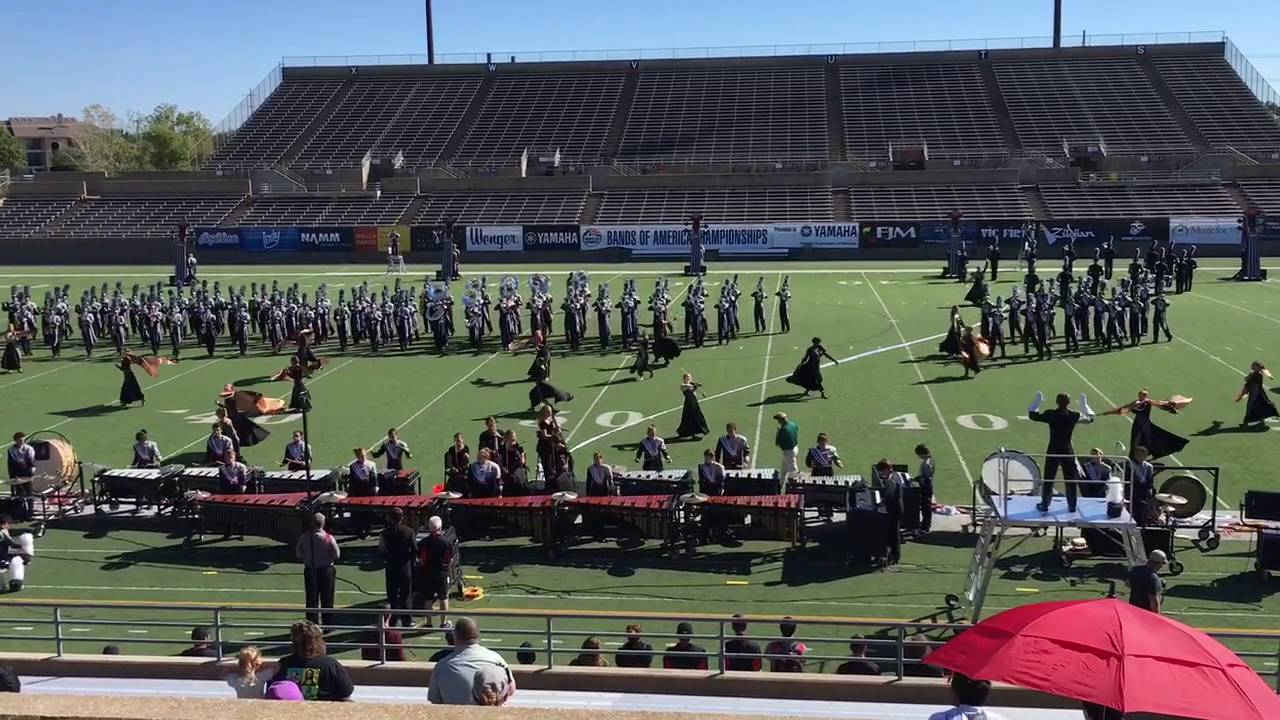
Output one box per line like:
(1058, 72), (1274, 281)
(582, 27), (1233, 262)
(618, 67), (828, 163)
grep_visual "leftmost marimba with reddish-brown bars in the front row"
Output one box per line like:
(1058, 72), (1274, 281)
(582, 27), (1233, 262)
(191, 492), (311, 543)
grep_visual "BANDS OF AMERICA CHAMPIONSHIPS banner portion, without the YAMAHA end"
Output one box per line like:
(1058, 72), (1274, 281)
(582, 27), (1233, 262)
(581, 224), (773, 255)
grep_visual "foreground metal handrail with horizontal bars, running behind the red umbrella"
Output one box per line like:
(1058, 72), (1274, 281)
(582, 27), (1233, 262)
(0, 601), (1280, 692)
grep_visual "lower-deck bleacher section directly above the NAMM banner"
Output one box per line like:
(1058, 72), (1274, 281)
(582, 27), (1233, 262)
(232, 195), (413, 227)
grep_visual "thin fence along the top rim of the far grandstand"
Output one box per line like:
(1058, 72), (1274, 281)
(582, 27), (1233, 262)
(280, 29), (1226, 68)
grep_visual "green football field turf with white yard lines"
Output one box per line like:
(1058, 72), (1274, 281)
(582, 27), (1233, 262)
(0, 260), (1280, 660)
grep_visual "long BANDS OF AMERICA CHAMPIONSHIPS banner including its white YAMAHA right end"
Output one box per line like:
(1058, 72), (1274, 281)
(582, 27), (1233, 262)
(581, 223), (858, 255)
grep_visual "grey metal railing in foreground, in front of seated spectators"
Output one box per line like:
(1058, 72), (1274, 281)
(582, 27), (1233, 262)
(0, 602), (1280, 692)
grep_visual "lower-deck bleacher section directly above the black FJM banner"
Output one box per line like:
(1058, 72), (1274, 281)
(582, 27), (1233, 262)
(849, 184), (1032, 220)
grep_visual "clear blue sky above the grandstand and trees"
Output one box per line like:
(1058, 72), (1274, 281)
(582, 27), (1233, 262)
(0, 0), (1280, 123)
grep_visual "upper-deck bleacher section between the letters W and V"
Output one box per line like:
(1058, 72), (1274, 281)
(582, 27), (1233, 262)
(453, 72), (623, 165)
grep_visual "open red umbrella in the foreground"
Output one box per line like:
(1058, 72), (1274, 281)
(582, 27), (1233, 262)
(925, 600), (1280, 720)
